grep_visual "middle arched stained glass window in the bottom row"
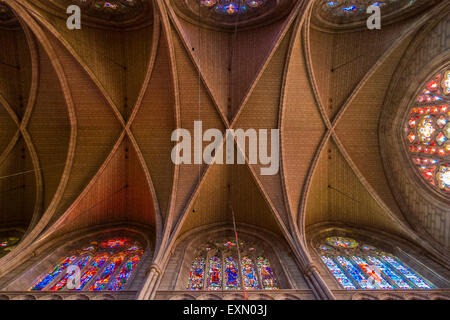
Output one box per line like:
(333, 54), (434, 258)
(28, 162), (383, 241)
(186, 239), (278, 290)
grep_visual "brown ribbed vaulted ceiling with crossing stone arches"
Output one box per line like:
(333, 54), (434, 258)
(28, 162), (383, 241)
(0, 0), (450, 276)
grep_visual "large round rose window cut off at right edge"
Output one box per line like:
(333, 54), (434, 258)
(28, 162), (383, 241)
(405, 70), (450, 195)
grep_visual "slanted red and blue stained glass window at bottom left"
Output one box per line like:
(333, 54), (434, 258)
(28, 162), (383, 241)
(30, 238), (143, 291)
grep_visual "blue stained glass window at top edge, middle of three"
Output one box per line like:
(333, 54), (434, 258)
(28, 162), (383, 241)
(198, 0), (267, 16)
